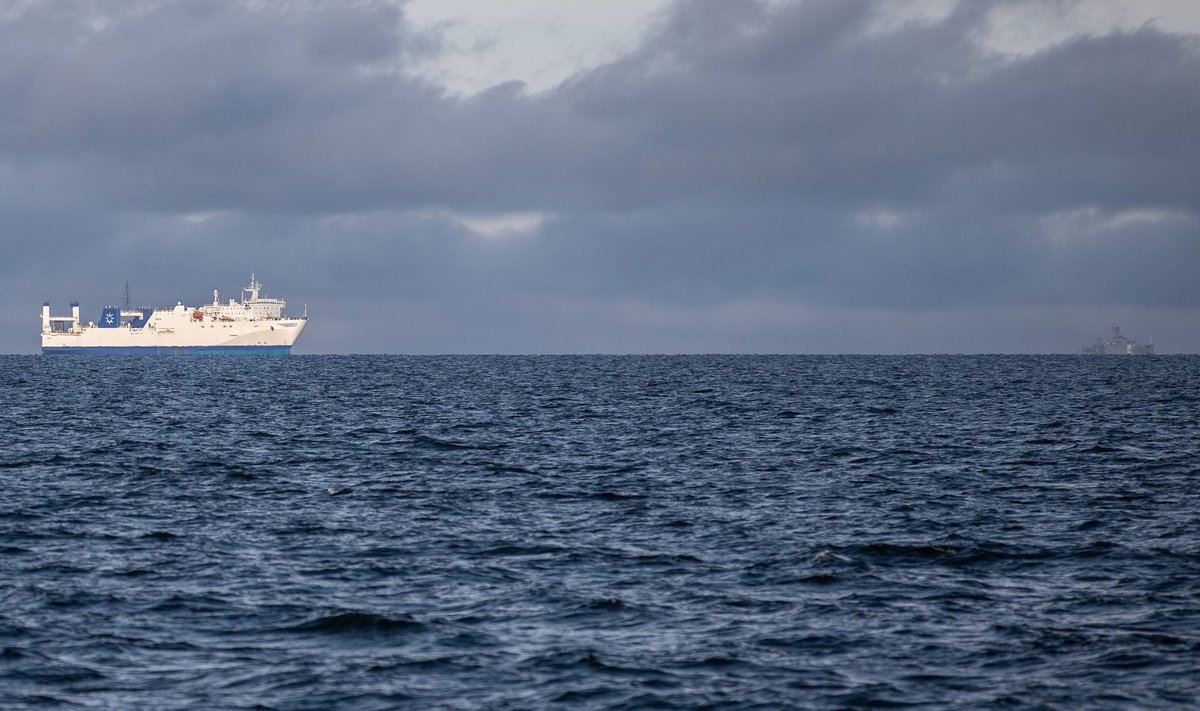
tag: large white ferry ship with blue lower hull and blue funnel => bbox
[42,274,308,356]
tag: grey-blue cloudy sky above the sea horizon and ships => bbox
[0,0,1200,353]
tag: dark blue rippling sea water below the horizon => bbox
[0,356,1200,710]
